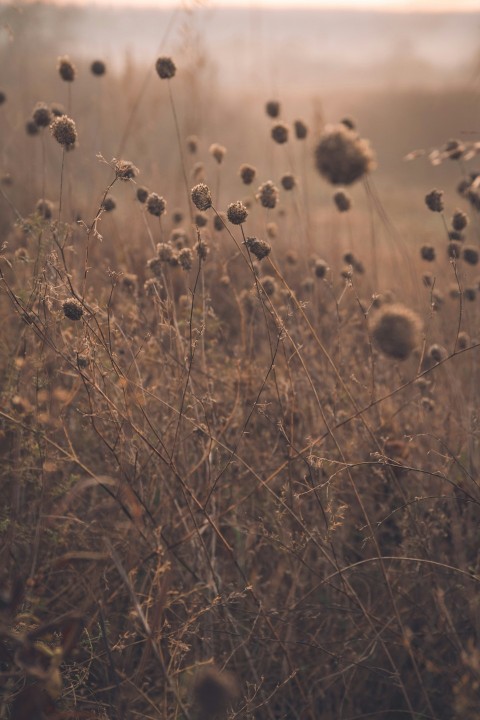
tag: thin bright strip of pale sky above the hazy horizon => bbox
[42,0,480,12]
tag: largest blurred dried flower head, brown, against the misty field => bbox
[315,124,375,185]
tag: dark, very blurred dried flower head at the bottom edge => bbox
[193,667,238,720]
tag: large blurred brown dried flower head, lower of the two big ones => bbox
[372,303,422,360]
